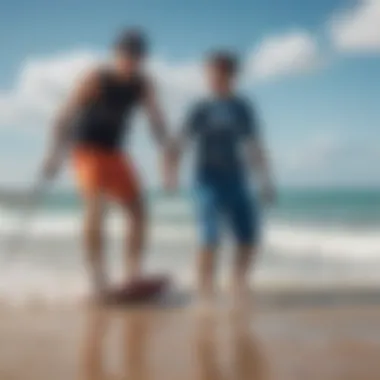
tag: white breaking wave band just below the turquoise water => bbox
[0,206,380,260]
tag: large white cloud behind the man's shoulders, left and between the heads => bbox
[0,51,202,127]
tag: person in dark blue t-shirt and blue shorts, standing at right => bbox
[168,51,274,301]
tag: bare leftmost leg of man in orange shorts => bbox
[84,194,107,296]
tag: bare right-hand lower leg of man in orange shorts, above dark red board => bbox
[125,197,146,281]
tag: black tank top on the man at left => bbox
[73,70,145,150]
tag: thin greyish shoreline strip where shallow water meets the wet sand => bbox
[0,281,380,312]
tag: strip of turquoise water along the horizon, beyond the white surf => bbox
[27,189,380,227]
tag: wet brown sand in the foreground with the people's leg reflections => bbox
[0,294,380,380]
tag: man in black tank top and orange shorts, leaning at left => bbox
[44,30,167,297]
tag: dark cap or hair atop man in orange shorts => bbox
[114,28,148,57]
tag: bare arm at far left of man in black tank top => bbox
[42,72,99,179]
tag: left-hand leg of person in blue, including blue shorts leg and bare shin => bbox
[197,186,219,299]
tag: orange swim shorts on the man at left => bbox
[73,146,141,203]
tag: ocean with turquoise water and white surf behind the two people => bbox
[0,189,380,303]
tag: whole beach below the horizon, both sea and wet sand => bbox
[0,191,380,380]
